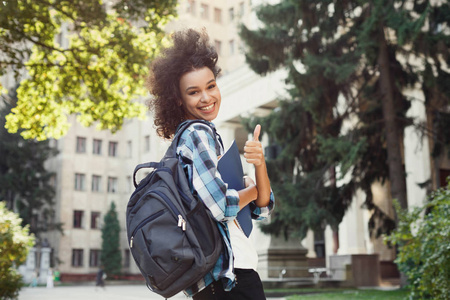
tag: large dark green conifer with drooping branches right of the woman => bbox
[240,0,450,236]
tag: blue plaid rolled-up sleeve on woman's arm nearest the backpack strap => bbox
[177,124,239,222]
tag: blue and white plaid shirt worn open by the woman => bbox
[177,123,275,297]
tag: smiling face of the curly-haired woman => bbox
[180,67,221,121]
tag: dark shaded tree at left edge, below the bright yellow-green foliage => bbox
[0,91,60,236]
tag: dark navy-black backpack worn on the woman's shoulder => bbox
[126,120,223,298]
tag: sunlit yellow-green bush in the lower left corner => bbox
[0,201,34,300]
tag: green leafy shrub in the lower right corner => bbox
[385,181,450,299]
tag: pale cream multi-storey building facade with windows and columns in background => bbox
[5,0,450,280]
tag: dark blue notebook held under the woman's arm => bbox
[217,141,253,237]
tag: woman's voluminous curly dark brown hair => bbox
[147,29,220,139]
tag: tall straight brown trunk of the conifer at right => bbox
[378,26,408,209]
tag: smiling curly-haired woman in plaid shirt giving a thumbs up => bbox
[148,29,274,300]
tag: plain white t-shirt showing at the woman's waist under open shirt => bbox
[228,220,258,270]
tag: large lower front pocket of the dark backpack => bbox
[130,209,194,290]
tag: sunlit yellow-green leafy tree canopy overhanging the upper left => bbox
[0,0,177,140]
